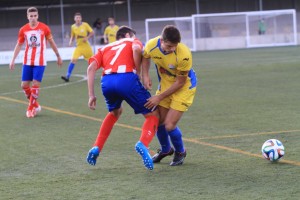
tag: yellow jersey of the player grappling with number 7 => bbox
[143,36,197,91]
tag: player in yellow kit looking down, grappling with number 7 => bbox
[142,25,197,166]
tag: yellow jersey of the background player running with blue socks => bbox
[71,22,93,47]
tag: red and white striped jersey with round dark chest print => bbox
[18,22,52,66]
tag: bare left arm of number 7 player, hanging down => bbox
[87,61,97,110]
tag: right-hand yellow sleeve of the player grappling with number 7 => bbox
[177,45,192,71]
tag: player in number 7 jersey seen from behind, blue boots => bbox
[87,26,158,170]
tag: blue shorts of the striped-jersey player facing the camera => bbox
[22,65,45,82]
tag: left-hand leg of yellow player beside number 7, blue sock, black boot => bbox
[152,106,174,163]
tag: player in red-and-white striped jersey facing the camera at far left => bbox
[9,7,62,118]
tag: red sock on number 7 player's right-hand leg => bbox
[140,115,158,147]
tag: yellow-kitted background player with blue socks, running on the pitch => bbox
[61,13,94,82]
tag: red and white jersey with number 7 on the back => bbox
[89,38,143,74]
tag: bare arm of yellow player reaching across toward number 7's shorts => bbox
[145,71,188,109]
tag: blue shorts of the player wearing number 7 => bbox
[101,73,151,114]
